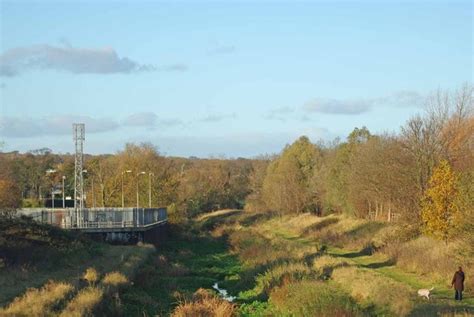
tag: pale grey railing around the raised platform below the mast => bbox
[18,208,168,229]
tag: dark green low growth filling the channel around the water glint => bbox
[123,222,241,316]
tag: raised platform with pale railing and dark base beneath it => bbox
[17,208,168,243]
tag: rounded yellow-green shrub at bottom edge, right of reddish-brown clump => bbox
[270,281,362,317]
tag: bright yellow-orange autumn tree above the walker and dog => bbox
[421,160,462,243]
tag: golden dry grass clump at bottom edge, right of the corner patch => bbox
[60,286,104,317]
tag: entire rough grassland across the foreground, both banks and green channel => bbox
[0,210,474,316]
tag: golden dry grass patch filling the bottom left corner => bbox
[0,281,74,316]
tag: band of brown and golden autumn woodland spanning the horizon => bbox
[0,84,474,243]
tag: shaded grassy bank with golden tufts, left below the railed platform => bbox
[0,219,154,316]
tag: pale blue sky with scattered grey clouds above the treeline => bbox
[0,0,474,157]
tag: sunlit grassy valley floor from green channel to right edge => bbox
[123,210,474,316]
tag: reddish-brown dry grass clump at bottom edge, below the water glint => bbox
[172,288,237,317]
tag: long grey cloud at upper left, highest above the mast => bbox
[0,45,187,77]
